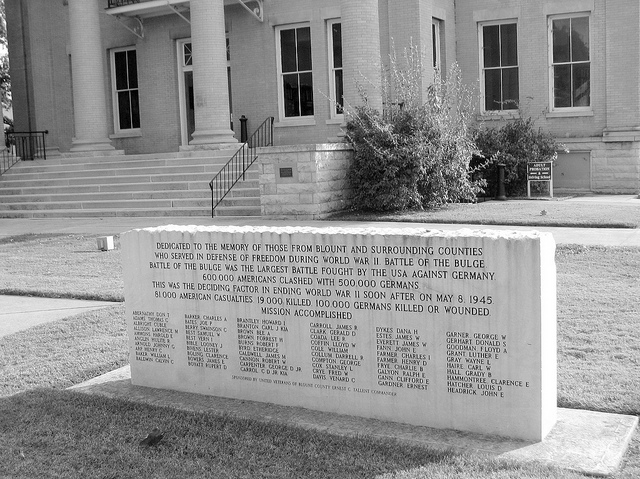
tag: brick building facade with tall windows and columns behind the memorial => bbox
[5,0,640,193]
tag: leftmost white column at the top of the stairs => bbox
[69,0,114,151]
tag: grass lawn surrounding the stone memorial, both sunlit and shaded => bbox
[0,235,640,479]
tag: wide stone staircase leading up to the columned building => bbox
[0,150,260,218]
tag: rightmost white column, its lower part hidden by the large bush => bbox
[340,0,382,111]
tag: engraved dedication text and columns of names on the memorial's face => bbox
[134,236,529,399]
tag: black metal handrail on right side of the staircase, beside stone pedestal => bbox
[209,116,273,217]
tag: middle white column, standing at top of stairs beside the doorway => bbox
[189,0,237,146]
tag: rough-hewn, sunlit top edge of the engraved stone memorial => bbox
[124,224,552,239]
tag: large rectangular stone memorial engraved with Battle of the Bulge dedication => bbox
[121,226,556,441]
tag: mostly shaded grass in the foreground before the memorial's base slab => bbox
[0,389,580,478]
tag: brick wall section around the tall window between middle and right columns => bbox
[232,0,348,145]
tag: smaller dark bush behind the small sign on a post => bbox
[471,113,563,196]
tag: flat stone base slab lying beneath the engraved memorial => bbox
[69,366,638,477]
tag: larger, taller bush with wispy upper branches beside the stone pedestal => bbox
[347,48,479,211]
